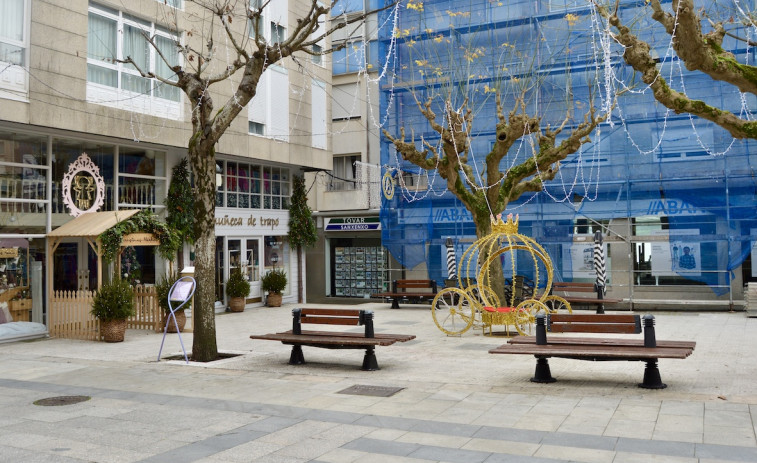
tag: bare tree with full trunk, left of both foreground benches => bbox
[124,0,384,361]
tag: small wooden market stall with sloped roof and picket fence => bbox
[47,210,174,340]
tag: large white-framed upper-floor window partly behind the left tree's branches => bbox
[87,4,181,117]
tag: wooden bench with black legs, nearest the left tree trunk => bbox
[250,308,415,371]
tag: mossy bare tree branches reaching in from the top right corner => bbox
[597,0,757,139]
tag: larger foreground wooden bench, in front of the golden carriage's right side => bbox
[489,314,696,389]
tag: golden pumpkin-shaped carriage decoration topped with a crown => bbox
[431,214,572,335]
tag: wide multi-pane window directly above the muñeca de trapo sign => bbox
[216,161,291,209]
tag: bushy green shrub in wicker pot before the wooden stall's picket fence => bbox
[91,278,134,342]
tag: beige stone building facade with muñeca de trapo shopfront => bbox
[0,0,332,321]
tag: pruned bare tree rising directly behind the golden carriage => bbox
[383,7,606,300]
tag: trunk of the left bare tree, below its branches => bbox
[189,132,218,362]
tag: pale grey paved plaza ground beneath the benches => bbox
[0,303,757,463]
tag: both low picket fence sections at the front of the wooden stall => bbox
[49,285,163,341]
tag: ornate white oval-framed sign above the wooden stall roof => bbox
[62,153,105,217]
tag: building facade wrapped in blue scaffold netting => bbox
[379,0,757,309]
